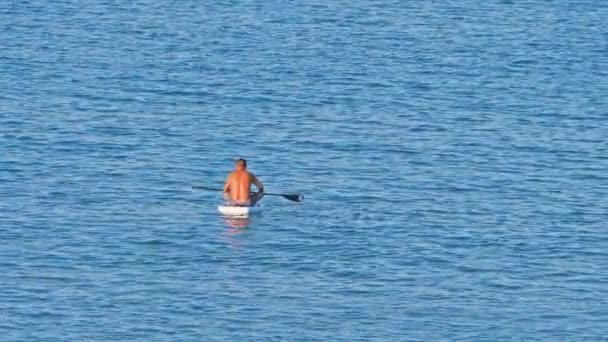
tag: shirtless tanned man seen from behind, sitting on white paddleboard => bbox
[224,158,264,207]
